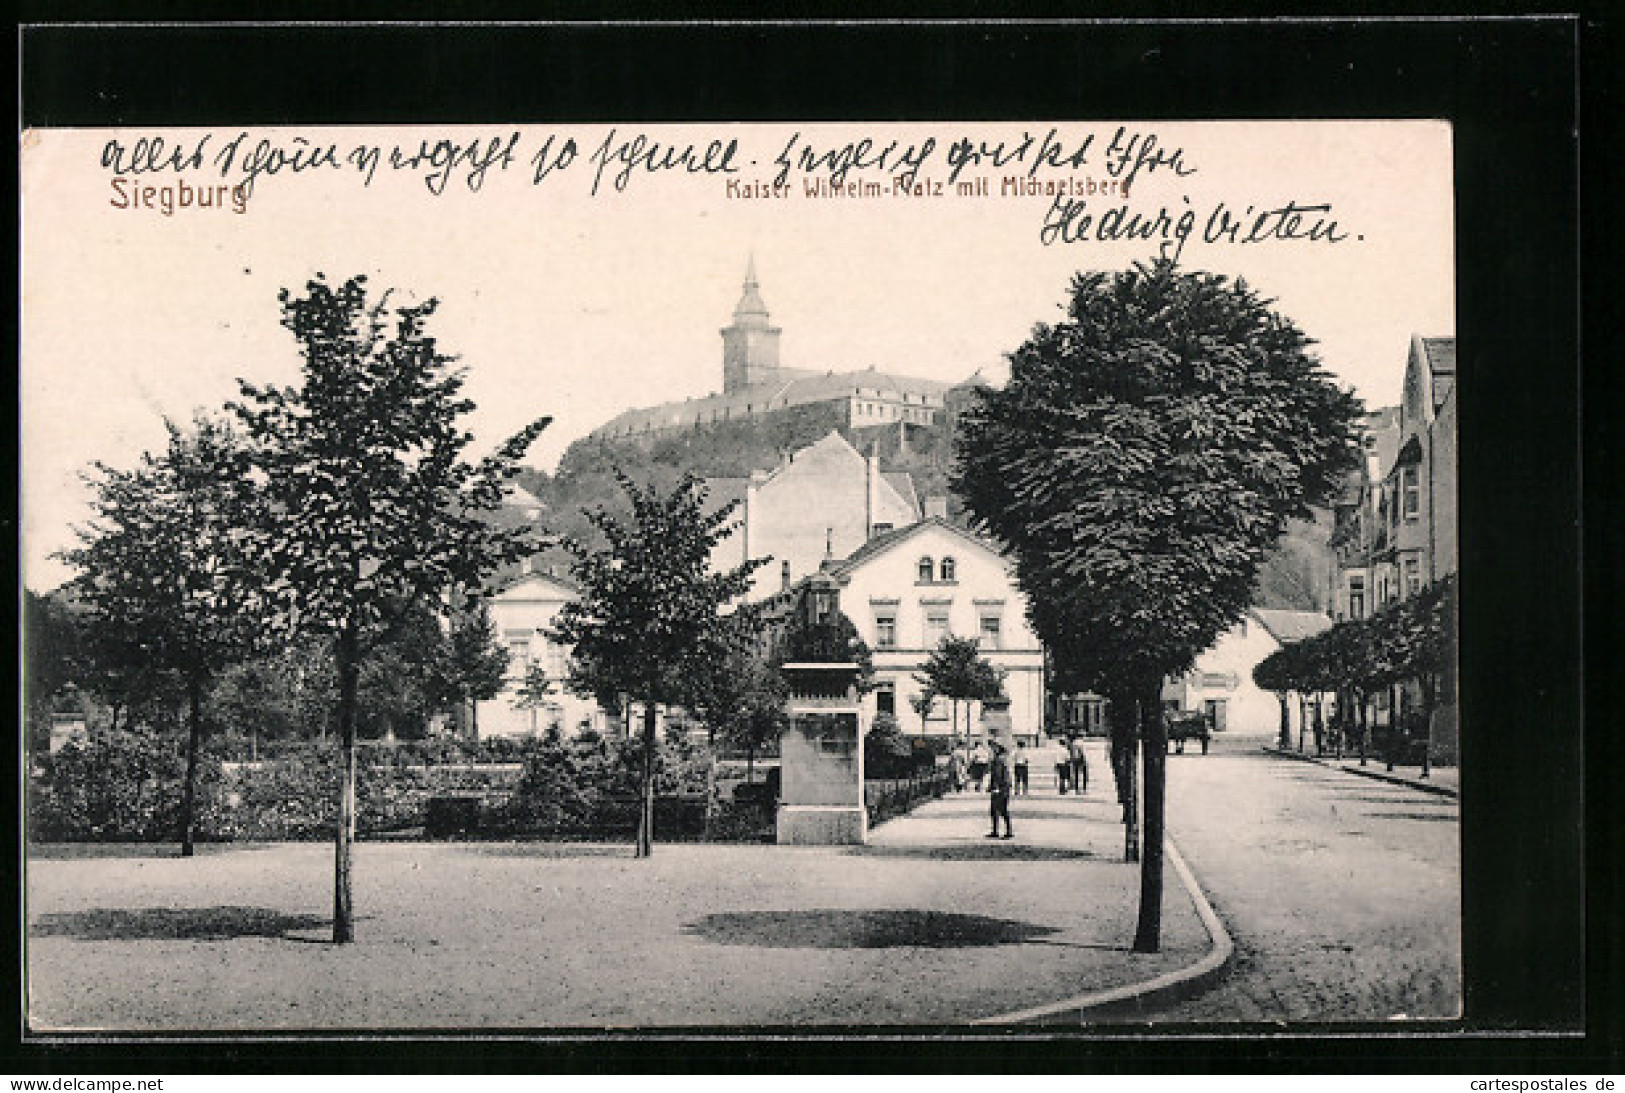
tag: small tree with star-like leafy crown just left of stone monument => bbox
[548,474,765,858]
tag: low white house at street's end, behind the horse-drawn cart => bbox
[1162,607,1331,739]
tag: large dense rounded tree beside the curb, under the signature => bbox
[954,261,1359,952]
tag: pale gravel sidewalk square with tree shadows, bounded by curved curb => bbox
[28,747,1214,1033]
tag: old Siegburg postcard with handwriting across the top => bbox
[20,119,1471,1036]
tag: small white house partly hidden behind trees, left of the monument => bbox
[475,573,611,737]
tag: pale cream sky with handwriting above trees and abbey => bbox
[20,120,1456,591]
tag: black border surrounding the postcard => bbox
[7,17,1599,1074]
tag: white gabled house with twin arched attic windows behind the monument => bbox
[829,516,1043,739]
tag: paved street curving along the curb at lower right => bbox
[1159,741,1461,1022]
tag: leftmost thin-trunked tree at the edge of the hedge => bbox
[63,417,263,856]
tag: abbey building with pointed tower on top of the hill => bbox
[590,260,954,442]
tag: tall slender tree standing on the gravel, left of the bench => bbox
[234,276,548,942]
